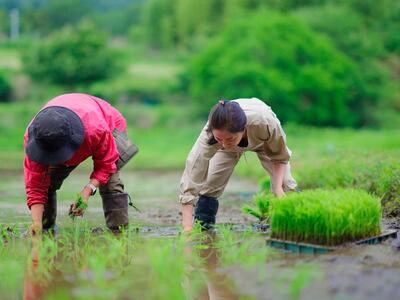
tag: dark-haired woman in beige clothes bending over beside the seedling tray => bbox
[179,98,297,231]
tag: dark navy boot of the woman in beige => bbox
[194,195,219,230]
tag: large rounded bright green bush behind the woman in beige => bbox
[188,12,364,126]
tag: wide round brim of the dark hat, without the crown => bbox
[25,106,85,165]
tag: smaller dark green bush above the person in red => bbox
[24,22,116,85]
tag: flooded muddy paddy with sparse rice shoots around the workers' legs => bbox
[0,171,400,300]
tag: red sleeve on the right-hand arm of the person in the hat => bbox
[90,130,119,185]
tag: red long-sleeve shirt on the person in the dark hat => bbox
[24,94,126,208]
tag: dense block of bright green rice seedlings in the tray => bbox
[270,189,381,246]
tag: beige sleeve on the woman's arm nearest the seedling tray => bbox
[260,118,291,164]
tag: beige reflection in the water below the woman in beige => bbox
[188,233,239,300]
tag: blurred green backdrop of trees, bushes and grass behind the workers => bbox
[0,0,400,216]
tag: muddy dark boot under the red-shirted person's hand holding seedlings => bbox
[101,193,129,232]
